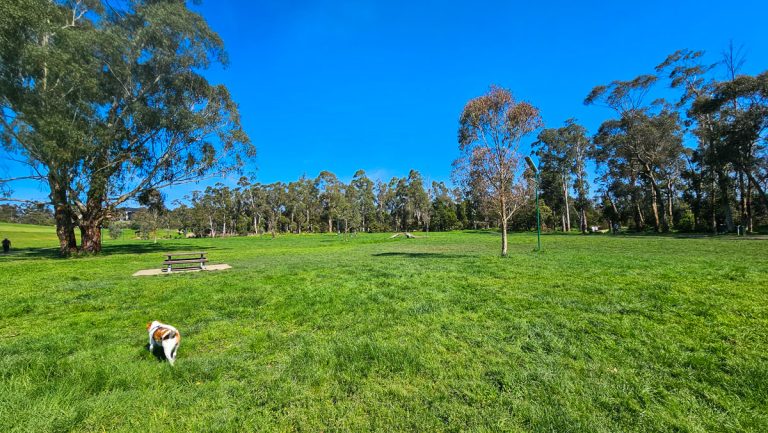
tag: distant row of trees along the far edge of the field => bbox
[147,170,510,236]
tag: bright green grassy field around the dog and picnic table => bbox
[0,224,768,432]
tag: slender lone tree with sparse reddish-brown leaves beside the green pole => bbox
[454,86,543,256]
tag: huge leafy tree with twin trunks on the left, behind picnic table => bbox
[0,0,253,253]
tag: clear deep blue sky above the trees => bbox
[6,0,768,201]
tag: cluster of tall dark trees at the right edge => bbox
[585,47,768,233]
